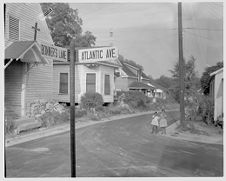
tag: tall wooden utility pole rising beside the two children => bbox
[178,2,185,124]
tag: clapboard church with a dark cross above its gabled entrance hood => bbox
[4,3,53,118]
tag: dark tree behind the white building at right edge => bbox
[200,62,223,95]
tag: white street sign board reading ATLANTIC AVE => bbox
[78,47,118,63]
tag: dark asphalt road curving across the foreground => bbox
[6,115,223,177]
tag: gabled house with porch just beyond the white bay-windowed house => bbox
[115,61,154,95]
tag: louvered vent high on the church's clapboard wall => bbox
[9,16,19,41]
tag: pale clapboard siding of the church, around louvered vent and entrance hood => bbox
[4,3,53,116]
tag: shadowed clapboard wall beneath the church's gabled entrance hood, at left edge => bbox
[5,61,24,118]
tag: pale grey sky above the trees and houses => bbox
[70,2,223,78]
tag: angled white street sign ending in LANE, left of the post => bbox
[40,43,68,62]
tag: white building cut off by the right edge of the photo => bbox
[210,68,224,121]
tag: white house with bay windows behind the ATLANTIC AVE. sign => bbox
[53,47,121,104]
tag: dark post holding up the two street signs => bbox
[70,39,76,177]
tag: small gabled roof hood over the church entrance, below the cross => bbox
[5,41,48,63]
